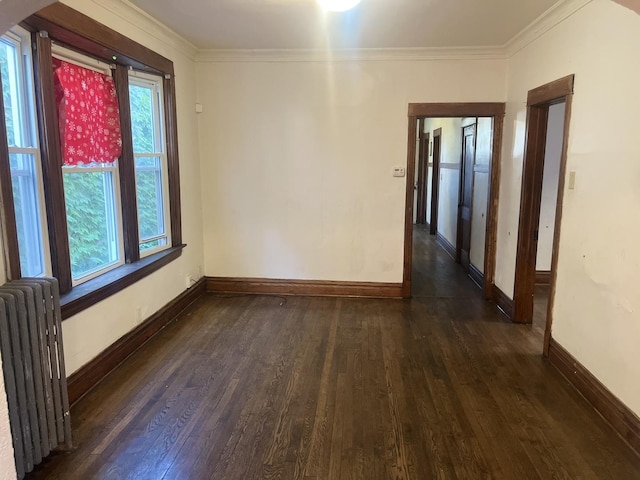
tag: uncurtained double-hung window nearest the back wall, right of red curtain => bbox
[129,70,171,257]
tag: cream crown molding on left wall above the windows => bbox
[62,0,198,60]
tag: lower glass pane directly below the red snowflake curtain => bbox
[63,169,120,280]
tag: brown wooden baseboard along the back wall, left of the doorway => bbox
[207,277,402,298]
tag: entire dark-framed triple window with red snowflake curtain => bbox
[0,3,184,318]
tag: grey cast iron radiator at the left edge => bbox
[0,278,72,478]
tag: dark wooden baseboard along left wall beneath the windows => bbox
[67,278,206,404]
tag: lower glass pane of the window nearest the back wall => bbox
[136,157,166,244]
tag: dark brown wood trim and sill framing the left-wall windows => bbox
[0,3,185,318]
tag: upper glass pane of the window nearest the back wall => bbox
[129,84,158,153]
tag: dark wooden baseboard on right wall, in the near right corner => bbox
[549,338,640,455]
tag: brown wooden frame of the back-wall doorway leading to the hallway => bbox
[402,102,506,299]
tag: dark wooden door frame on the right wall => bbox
[512,75,574,336]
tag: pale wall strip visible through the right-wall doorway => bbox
[536,103,566,271]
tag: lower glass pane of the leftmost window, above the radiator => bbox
[9,153,45,277]
